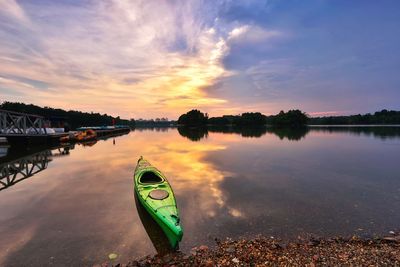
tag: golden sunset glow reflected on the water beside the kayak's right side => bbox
[91,131,248,233]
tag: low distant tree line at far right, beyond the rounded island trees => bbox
[310,109,400,125]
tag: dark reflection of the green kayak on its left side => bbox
[134,194,175,255]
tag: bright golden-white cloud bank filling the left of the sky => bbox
[0,1,234,117]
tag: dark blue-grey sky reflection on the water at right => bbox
[202,131,400,241]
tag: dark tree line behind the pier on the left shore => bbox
[0,102,135,129]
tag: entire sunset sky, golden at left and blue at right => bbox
[0,0,400,119]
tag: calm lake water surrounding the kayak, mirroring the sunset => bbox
[0,127,400,266]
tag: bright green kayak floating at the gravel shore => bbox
[134,157,183,248]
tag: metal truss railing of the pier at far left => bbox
[0,109,47,135]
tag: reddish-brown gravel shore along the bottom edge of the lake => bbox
[106,234,400,267]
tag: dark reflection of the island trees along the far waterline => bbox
[178,126,400,141]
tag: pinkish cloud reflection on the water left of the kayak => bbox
[0,138,156,265]
